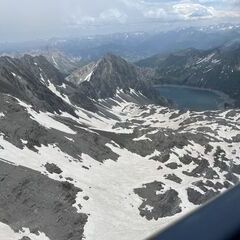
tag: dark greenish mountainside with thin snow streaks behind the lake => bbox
[138,41,240,106]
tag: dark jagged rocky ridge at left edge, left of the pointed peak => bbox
[0,55,73,113]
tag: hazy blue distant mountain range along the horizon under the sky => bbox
[0,24,240,63]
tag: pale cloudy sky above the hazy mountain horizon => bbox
[0,0,240,41]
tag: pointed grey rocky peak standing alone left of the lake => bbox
[67,54,164,104]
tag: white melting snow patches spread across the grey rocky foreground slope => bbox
[0,89,240,240]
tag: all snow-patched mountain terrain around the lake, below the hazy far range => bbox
[0,39,240,240]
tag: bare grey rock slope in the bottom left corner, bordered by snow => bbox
[0,162,87,240]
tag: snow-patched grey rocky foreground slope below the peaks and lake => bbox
[0,54,240,240]
